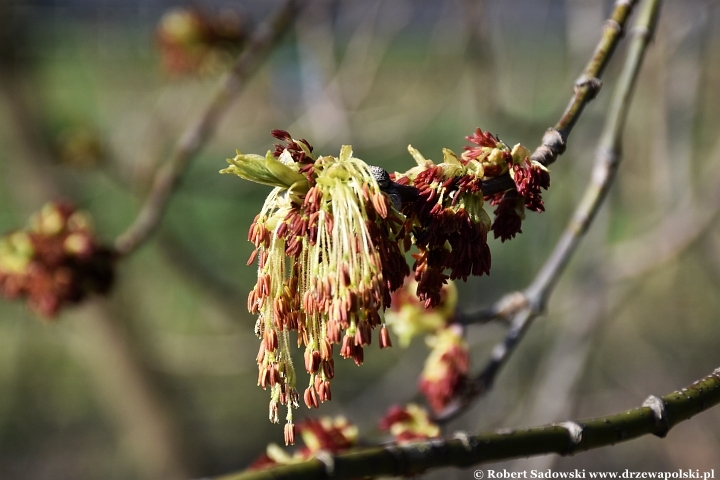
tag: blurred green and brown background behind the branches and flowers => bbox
[0,0,720,480]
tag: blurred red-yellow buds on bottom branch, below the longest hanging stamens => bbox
[248,417,358,470]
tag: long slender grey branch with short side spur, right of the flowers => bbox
[438,0,660,421]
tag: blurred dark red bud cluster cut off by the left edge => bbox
[0,202,113,318]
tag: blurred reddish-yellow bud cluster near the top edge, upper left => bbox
[157,8,245,75]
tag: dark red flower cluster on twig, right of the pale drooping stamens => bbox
[394,128,550,307]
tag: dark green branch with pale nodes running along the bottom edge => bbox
[218,369,720,480]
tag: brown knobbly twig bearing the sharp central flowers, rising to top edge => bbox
[483,0,638,195]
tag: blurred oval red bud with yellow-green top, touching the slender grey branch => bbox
[419,324,470,413]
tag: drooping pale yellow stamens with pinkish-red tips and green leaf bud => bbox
[222,130,409,443]
